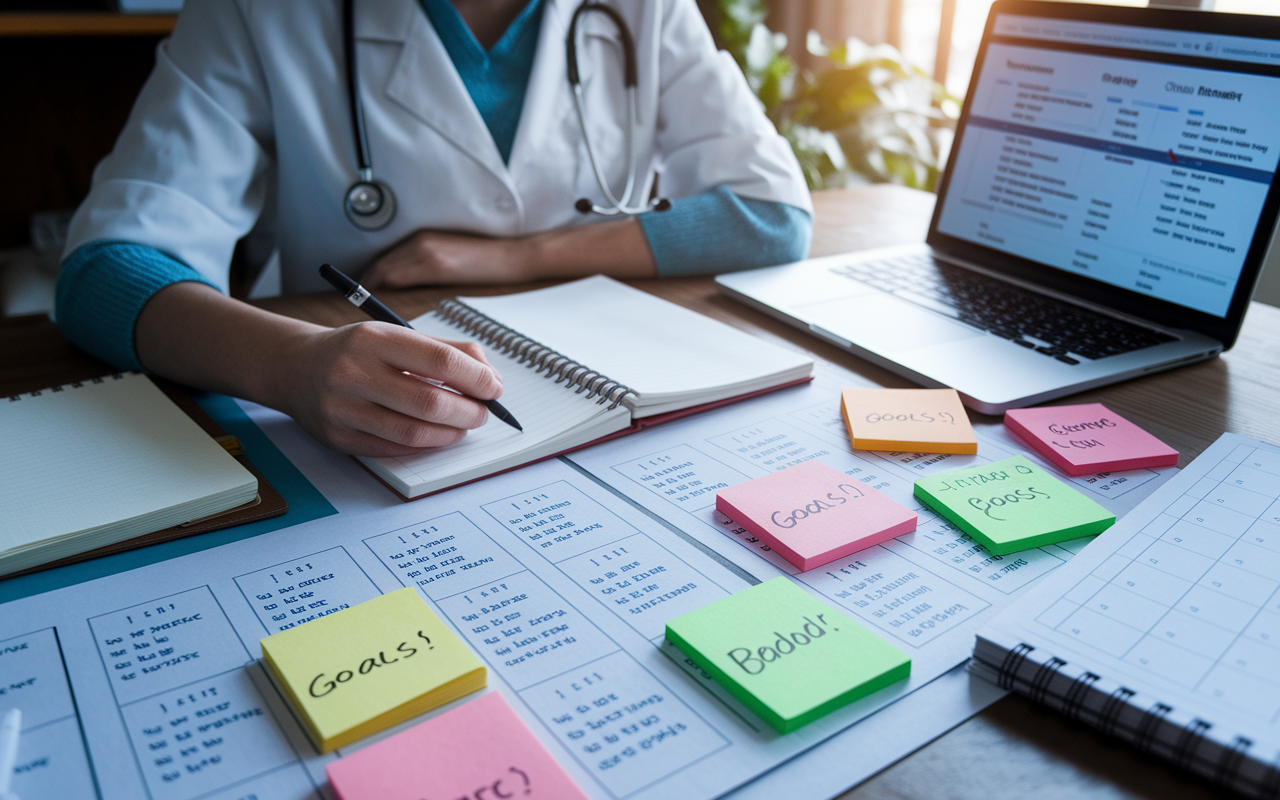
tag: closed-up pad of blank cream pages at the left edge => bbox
[0,372,257,575]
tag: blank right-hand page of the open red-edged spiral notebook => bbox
[458,275,813,416]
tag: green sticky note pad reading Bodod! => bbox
[667,577,911,733]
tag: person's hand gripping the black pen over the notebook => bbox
[276,323,502,456]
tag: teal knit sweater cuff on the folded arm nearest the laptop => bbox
[637,187,813,278]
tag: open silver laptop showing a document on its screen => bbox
[716,0,1280,413]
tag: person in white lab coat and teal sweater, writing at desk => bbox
[56,0,812,456]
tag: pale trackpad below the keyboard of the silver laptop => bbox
[792,292,987,355]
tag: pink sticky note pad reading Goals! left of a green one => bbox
[716,461,915,570]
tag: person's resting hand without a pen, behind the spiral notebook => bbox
[360,230,534,289]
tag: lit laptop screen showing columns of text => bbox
[934,5,1280,317]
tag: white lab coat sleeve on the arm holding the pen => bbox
[65,0,274,292]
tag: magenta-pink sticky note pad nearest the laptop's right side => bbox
[1005,403,1178,475]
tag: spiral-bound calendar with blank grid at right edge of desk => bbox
[970,434,1280,797]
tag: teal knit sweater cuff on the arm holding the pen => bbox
[55,242,218,370]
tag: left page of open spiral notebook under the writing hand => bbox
[361,314,631,497]
